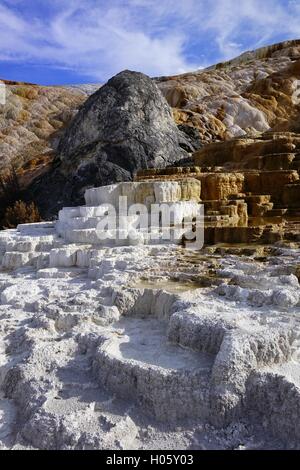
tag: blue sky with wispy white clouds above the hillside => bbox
[0,0,300,84]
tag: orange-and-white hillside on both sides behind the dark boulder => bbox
[0,40,300,216]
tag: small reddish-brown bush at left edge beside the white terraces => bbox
[2,201,42,228]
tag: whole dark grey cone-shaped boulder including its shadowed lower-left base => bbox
[32,70,193,217]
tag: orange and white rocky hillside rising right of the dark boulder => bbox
[157,40,300,143]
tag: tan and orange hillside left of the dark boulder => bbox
[0,80,87,173]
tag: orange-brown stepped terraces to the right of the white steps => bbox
[137,132,300,244]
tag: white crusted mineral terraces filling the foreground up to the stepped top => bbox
[0,181,300,449]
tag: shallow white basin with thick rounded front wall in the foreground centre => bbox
[93,318,215,422]
